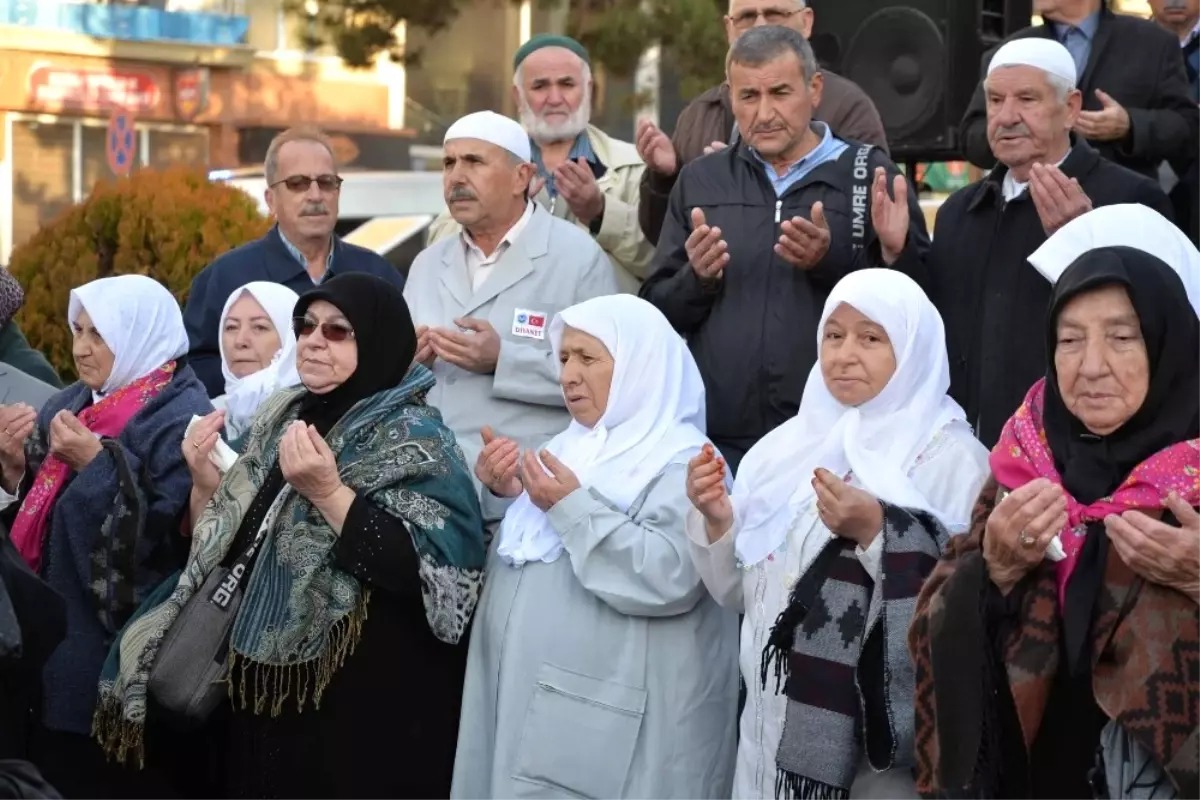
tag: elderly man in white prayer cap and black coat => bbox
[876,38,1170,447]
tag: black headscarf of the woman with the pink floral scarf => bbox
[1043,247,1200,673]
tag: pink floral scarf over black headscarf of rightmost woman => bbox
[989,378,1200,607]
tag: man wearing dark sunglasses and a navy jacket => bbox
[184,128,404,397]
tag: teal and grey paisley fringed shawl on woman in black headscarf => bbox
[94,366,485,760]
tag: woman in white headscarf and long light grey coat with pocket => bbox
[451,295,737,800]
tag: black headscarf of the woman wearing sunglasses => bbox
[293,272,416,435]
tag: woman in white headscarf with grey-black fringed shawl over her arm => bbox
[688,270,988,800]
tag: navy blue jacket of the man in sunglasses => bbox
[184,227,404,397]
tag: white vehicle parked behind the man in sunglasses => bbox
[209,168,445,275]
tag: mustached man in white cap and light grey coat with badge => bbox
[404,112,618,479]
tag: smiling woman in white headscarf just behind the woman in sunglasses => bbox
[212,281,300,450]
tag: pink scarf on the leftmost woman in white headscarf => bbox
[12,361,175,571]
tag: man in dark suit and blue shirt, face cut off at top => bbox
[959,0,1200,179]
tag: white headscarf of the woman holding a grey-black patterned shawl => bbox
[733,270,970,566]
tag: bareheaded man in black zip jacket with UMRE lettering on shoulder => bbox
[641,25,929,469]
